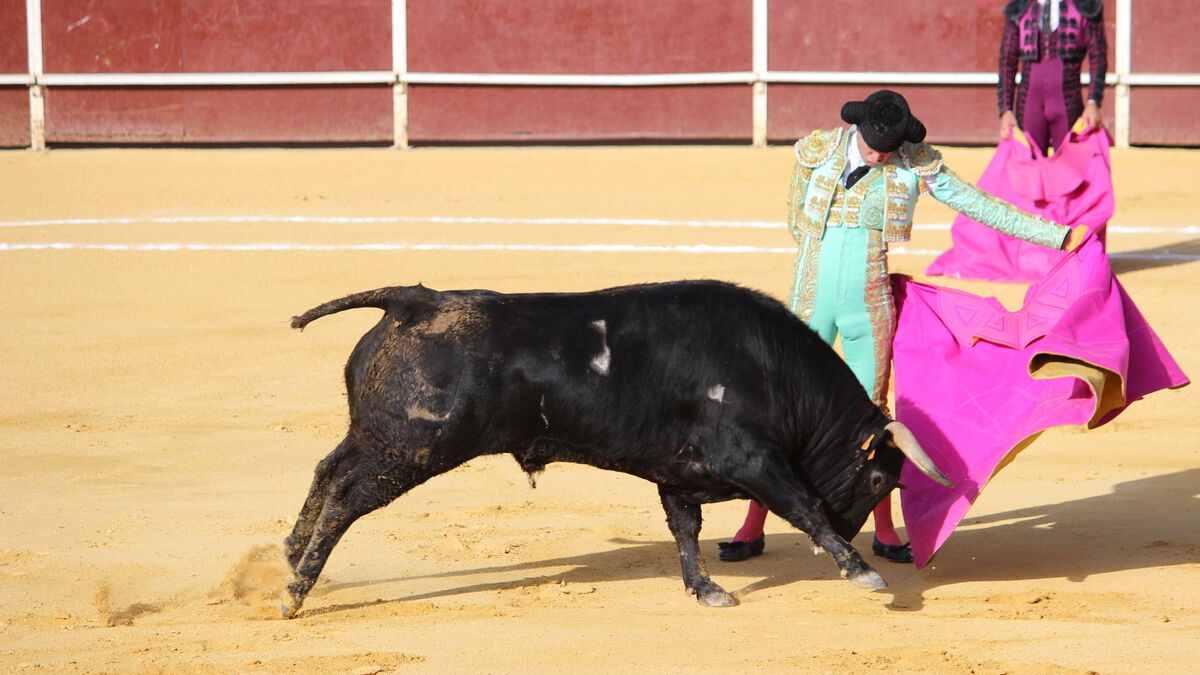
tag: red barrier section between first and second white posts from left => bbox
[42,0,392,143]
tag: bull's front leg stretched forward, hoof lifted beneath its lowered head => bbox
[728,453,888,589]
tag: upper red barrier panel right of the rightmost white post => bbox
[1128,2,1200,72]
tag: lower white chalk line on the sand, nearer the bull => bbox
[0,241,1200,262]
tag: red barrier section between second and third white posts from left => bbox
[408,0,751,142]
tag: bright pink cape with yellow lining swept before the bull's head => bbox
[893,235,1188,567]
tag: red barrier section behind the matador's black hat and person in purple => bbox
[767,0,1115,143]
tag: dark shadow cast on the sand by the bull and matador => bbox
[301,468,1200,616]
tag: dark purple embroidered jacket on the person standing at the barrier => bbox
[997,0,1109,119]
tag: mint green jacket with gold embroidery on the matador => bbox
[787,127,1069,249]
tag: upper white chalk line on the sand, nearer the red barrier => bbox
[0,216,1200,234]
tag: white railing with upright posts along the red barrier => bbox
[9,0,1200,150]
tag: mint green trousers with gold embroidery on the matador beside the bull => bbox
[792,226,895,411]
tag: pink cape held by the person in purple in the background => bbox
[925,127,1114,283]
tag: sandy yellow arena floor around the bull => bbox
[0,140,1200,675]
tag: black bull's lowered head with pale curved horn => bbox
[826,422,954,540]
